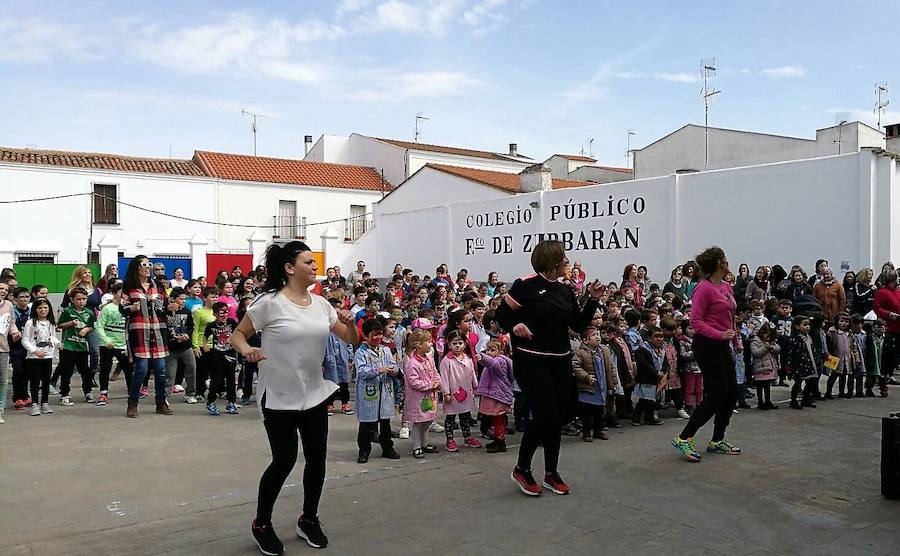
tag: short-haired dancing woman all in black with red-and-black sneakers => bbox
[497,241,603,496]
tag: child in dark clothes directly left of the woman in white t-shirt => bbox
[203,301,238,416]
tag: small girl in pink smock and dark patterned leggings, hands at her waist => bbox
[440,329,481,452]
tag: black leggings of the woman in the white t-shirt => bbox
[256,399,328,524]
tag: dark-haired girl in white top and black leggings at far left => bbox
[22,298,60,416]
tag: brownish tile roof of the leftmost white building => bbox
[0,147,203,176]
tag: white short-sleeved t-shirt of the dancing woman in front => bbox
[247,292,338,411]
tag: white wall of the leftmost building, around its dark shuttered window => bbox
[0,164,217,263]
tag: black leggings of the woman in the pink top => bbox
[680,334,737,442]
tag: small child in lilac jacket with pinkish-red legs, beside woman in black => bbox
[477,340,516,454]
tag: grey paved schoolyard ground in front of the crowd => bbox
[0,381,900,556]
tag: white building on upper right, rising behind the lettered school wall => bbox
[634,122,885,179]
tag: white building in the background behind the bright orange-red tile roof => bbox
[304,133,534,184]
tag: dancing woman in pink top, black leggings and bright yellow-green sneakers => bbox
[672,247,741,462]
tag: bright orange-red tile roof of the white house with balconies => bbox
[194,151,393,191]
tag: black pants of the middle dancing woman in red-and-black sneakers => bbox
[514,350,575,473]
